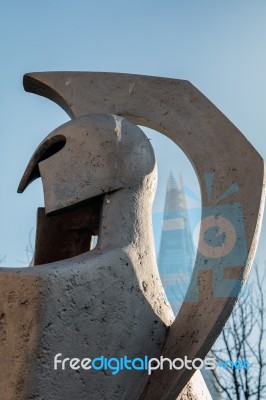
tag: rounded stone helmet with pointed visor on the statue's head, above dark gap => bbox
[18,114,156,214]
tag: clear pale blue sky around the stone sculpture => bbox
[0,0,266,272]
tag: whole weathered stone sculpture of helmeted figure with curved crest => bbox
[0,72,264,400]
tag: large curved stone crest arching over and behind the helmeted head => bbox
[21,72,265,400]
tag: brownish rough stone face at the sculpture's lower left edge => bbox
[0,269,42,400]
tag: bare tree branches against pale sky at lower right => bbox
[212,264,266,400]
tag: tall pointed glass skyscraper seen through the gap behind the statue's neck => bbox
[158,173,195,315]
